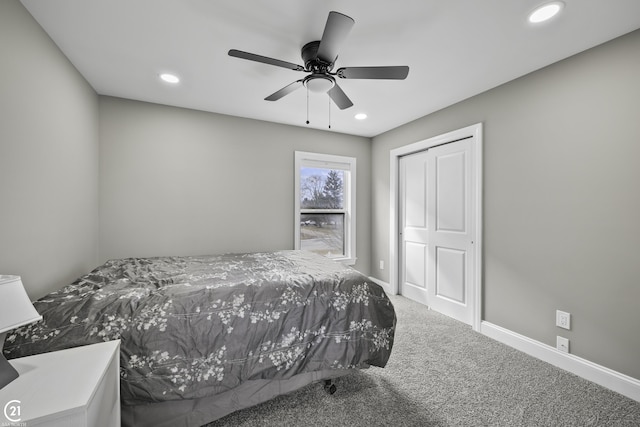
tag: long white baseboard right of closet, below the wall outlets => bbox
[480,321,640,402]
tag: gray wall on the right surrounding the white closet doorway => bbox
[371,31,640,379]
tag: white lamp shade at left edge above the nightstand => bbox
[0,275,42,334]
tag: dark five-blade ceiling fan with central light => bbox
[229,12,409,110]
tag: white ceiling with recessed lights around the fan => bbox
[22,0,640,137]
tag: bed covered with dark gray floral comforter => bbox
[4,251,396,427]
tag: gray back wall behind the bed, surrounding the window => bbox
[100,97,371,274]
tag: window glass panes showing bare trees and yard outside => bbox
[300,167,346,257]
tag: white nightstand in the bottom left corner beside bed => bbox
[0,341,120,427]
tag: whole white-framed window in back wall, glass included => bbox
[295,151,356,264]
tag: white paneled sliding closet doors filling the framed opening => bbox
[398,138,475,324]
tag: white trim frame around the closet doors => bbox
[389,123,483,331]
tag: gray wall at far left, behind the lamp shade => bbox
[0,0,98,299]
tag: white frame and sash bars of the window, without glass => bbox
[294,151,357,265]
